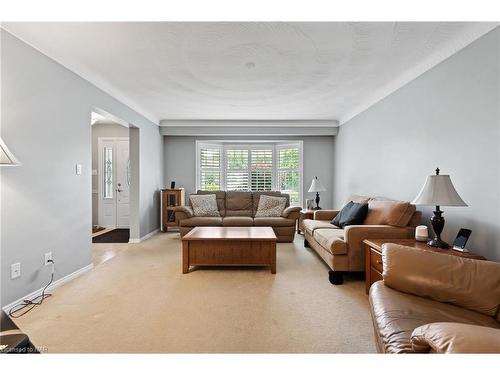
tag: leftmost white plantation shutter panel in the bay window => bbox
[198,144,222,191]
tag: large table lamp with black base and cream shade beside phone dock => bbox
[411,168,467,249]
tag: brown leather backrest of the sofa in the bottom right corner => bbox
[382,243,500,317]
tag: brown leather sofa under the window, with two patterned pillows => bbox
[174,190,302,242]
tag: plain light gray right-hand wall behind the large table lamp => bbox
[334,28,500,261]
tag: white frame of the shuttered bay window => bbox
[196,140,304,207]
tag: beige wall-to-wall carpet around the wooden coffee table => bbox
[16,233,375,353]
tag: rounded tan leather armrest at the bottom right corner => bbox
[411,323,500,354]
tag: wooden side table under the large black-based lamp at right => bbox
[363,238,486,294]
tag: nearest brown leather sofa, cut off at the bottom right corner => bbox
[369,244,500,353]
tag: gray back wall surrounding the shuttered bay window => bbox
[163,137,334,208]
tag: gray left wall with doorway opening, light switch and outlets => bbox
[0,30,163,306]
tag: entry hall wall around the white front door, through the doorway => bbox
[91,123,129,225]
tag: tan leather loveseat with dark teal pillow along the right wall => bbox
[303,195,422,284]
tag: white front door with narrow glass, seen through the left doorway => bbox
[97,138,130,228]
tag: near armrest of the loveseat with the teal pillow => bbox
[344,225,415,248]
